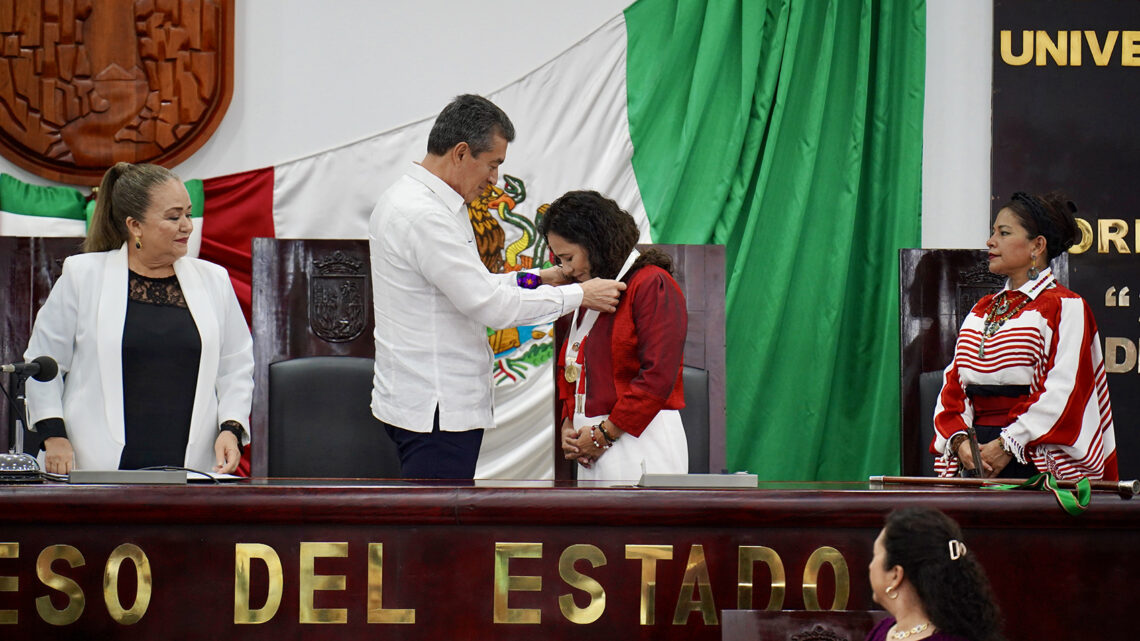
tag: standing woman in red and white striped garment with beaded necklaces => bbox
[930,192,1118,479]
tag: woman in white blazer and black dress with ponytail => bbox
[25,163,253,473]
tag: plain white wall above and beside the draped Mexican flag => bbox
[0,0,992,248]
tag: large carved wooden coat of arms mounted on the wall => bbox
[0,0,234,185]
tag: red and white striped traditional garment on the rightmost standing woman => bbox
[930,269,1118,480]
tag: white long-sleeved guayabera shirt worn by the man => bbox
[368,164,583,432]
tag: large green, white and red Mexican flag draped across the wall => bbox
[0,0,926,480]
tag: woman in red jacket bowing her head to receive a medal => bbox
[539,192,689,480]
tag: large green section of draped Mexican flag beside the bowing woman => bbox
[626,0,926,480]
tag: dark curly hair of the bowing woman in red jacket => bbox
[538,192,673,278]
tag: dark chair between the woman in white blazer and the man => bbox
[251,238,378,477]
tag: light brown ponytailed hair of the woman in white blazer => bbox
[83,162,178,252]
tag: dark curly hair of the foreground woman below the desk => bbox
[882,508,1002,641]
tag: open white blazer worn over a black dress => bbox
[24,244,253,471]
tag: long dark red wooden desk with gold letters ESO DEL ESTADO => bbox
[0,479,1140,640]
